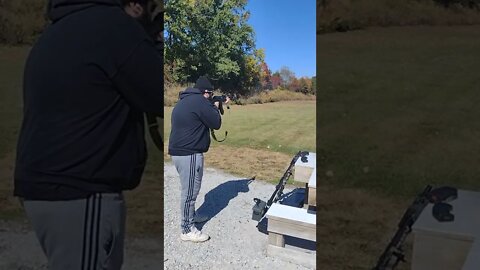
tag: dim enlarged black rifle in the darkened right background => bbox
[373,185,457,270]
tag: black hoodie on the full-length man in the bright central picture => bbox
[168,88,222,156]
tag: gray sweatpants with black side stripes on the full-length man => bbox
[172,153,203,233]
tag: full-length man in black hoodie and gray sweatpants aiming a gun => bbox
[168,77,229,242]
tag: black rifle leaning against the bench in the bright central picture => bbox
[252,151,308,221]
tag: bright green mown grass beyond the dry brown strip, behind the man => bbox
[164,101,316,154]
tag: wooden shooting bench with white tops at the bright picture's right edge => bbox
[266,152,316,269]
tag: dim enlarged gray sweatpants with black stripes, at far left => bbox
[24,193,125,270]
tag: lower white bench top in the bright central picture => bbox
[266,203,317,228]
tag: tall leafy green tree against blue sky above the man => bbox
[165,0,264,93]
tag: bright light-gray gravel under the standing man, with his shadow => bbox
[164,163,314,270]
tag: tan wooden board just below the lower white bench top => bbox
[267,218,317,241]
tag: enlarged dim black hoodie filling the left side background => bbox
[14,0,163,200]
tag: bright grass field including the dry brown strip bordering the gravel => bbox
[164,101,316,183]
